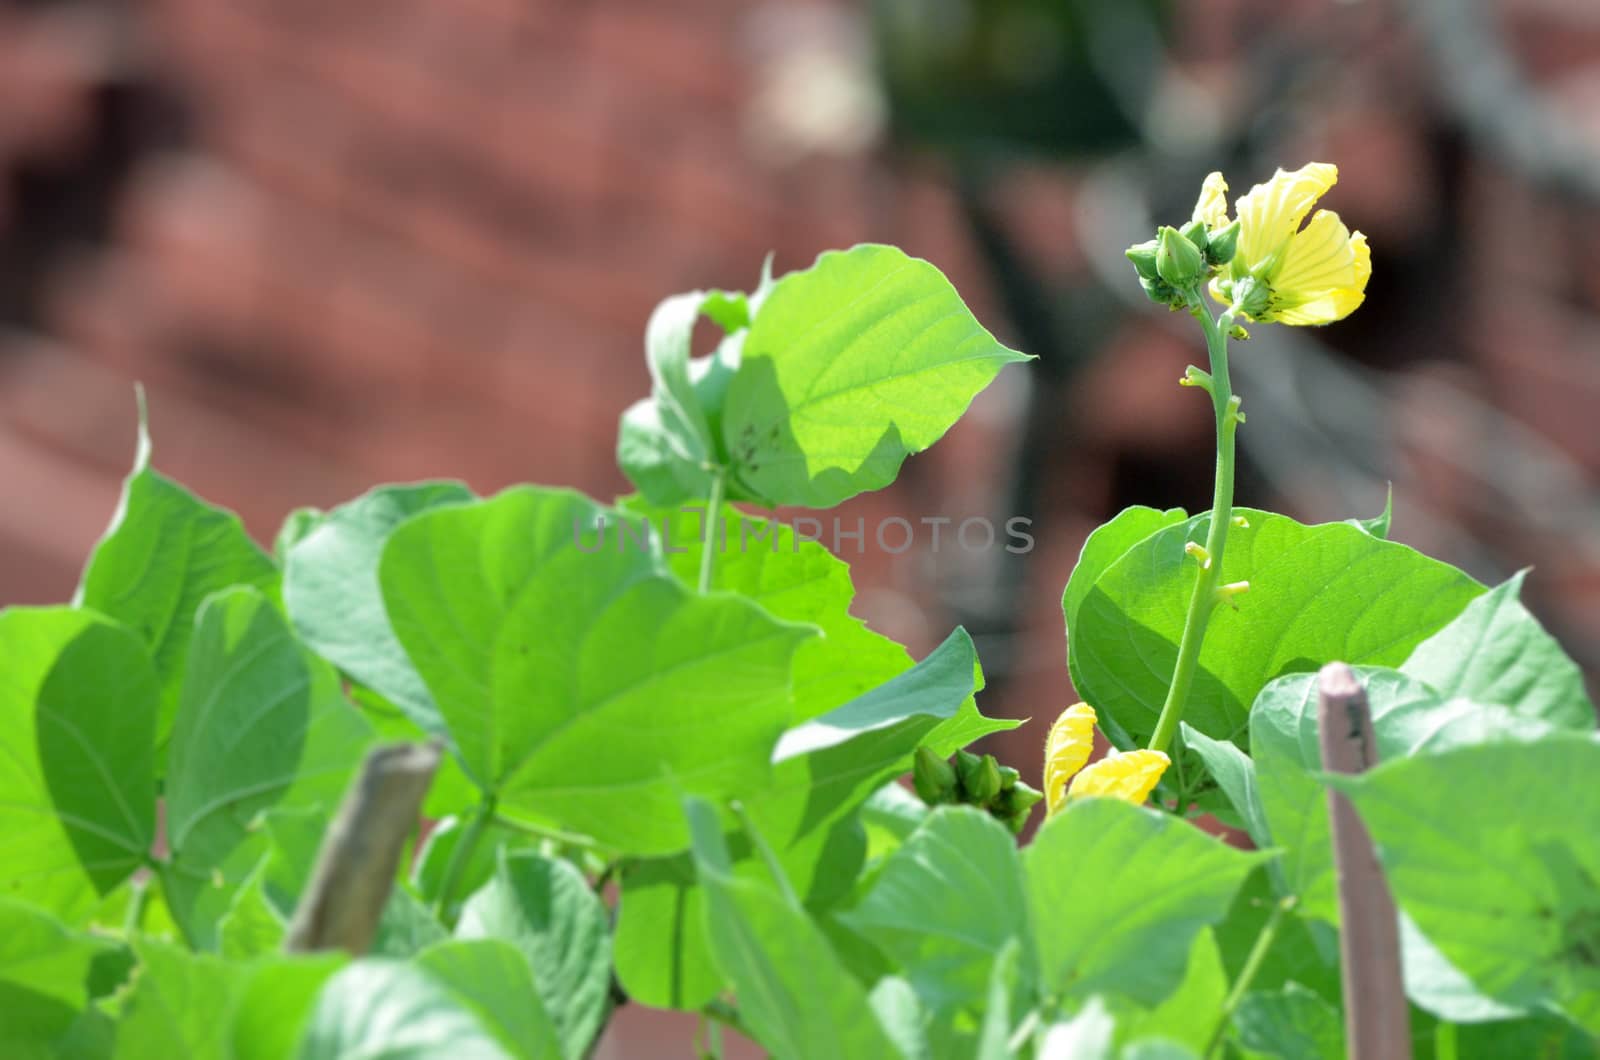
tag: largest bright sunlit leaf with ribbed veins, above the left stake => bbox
[379,487,814,855]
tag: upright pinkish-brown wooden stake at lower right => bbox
[1317,663,1411,1060]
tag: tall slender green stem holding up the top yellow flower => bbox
[1149,302,1238,751]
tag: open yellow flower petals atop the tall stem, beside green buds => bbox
[1195,162,1373,325]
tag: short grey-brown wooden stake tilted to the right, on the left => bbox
[283,743,440,956]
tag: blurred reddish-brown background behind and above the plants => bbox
[0,0,1600,1055]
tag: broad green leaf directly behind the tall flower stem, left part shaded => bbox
[1069,509,1482,743]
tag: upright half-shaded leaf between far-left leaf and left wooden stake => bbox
[166,588,371,890]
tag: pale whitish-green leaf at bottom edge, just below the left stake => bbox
[298,958,515,1060]
